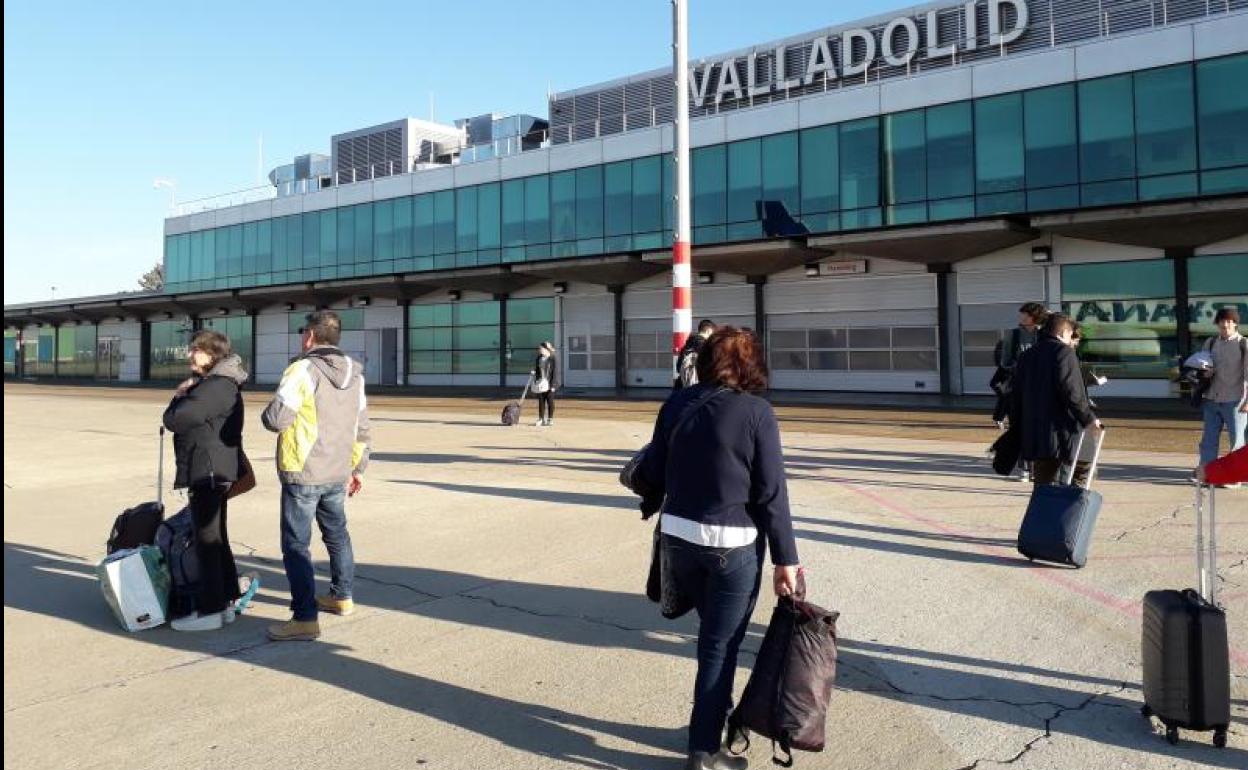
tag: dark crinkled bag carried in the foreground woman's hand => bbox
[728,597,840,768]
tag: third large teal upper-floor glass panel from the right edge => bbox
[1078,75,1136,182]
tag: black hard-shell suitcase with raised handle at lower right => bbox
[1141,485,1231,748]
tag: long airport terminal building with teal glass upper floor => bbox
[5,0,1248,397]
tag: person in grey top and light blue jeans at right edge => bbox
[1201,307,1248,487]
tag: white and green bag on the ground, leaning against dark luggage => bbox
[95,545,170,631]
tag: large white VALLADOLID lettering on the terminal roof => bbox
[689,0,1030,107]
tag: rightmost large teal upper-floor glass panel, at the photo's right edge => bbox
[1196,54,1248,168]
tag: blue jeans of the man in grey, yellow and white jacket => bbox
[282,484,356,620]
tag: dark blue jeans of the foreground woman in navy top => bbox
[663,535,766,754]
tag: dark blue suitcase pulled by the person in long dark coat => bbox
[1018,429,1104,567]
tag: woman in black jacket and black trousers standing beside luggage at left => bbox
[163,329,247,631]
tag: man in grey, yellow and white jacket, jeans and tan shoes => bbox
[261,311,372,641]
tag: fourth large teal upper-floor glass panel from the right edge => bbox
[1023,85,1080,187]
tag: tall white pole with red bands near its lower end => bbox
[671,0,694,376]
